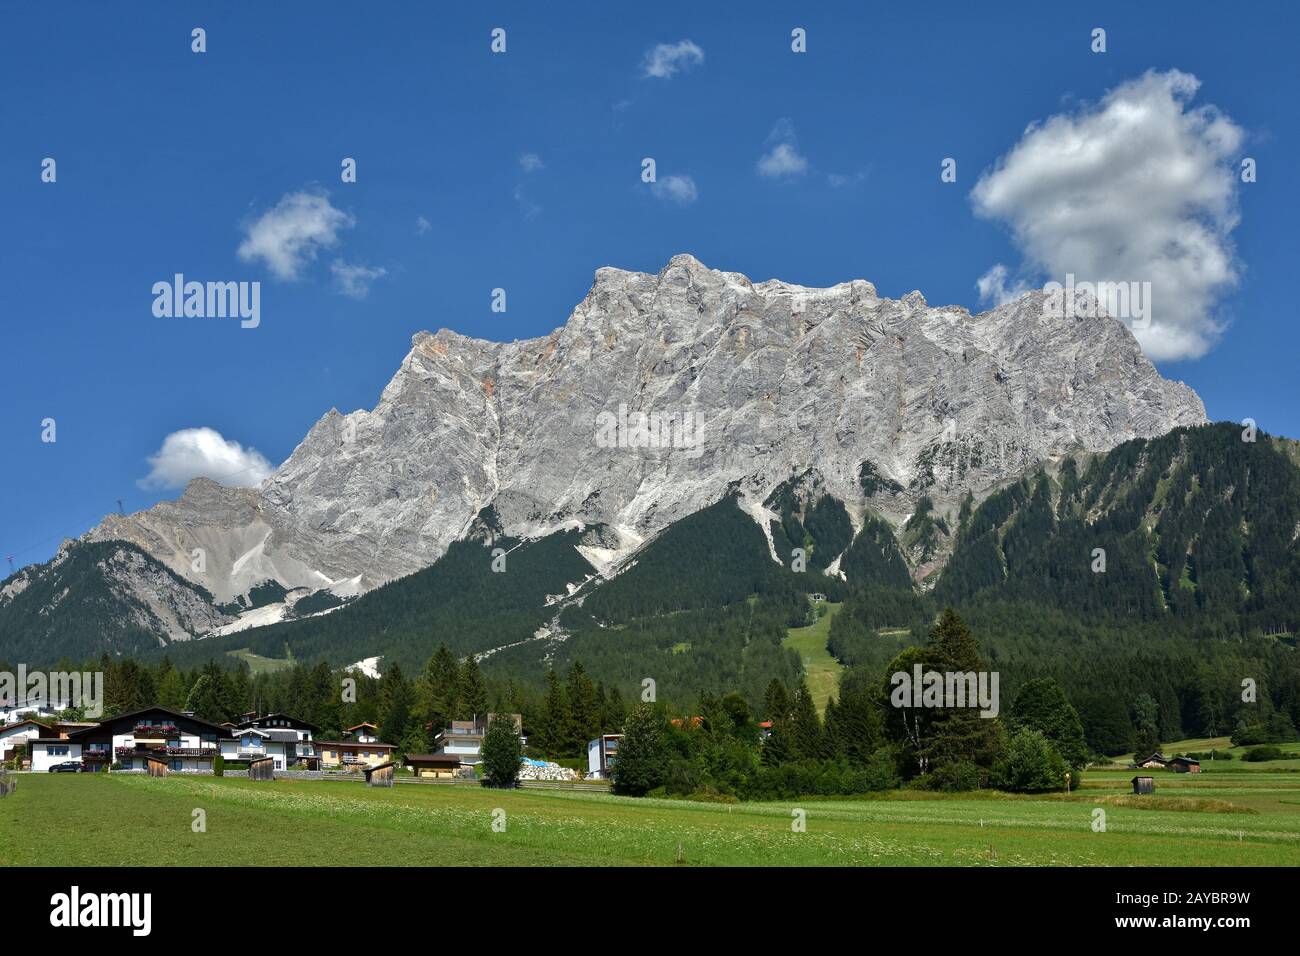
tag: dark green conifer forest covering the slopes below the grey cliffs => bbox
[7,425,1300,797]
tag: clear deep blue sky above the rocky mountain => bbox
[0,3,1300,572]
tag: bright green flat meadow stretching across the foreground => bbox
[0,771,1300,866]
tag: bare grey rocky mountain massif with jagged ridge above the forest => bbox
[87,255,1205,602]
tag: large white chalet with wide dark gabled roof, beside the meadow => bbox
[29,706,226,773]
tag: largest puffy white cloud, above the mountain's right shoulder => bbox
[971,70,1243,359]
